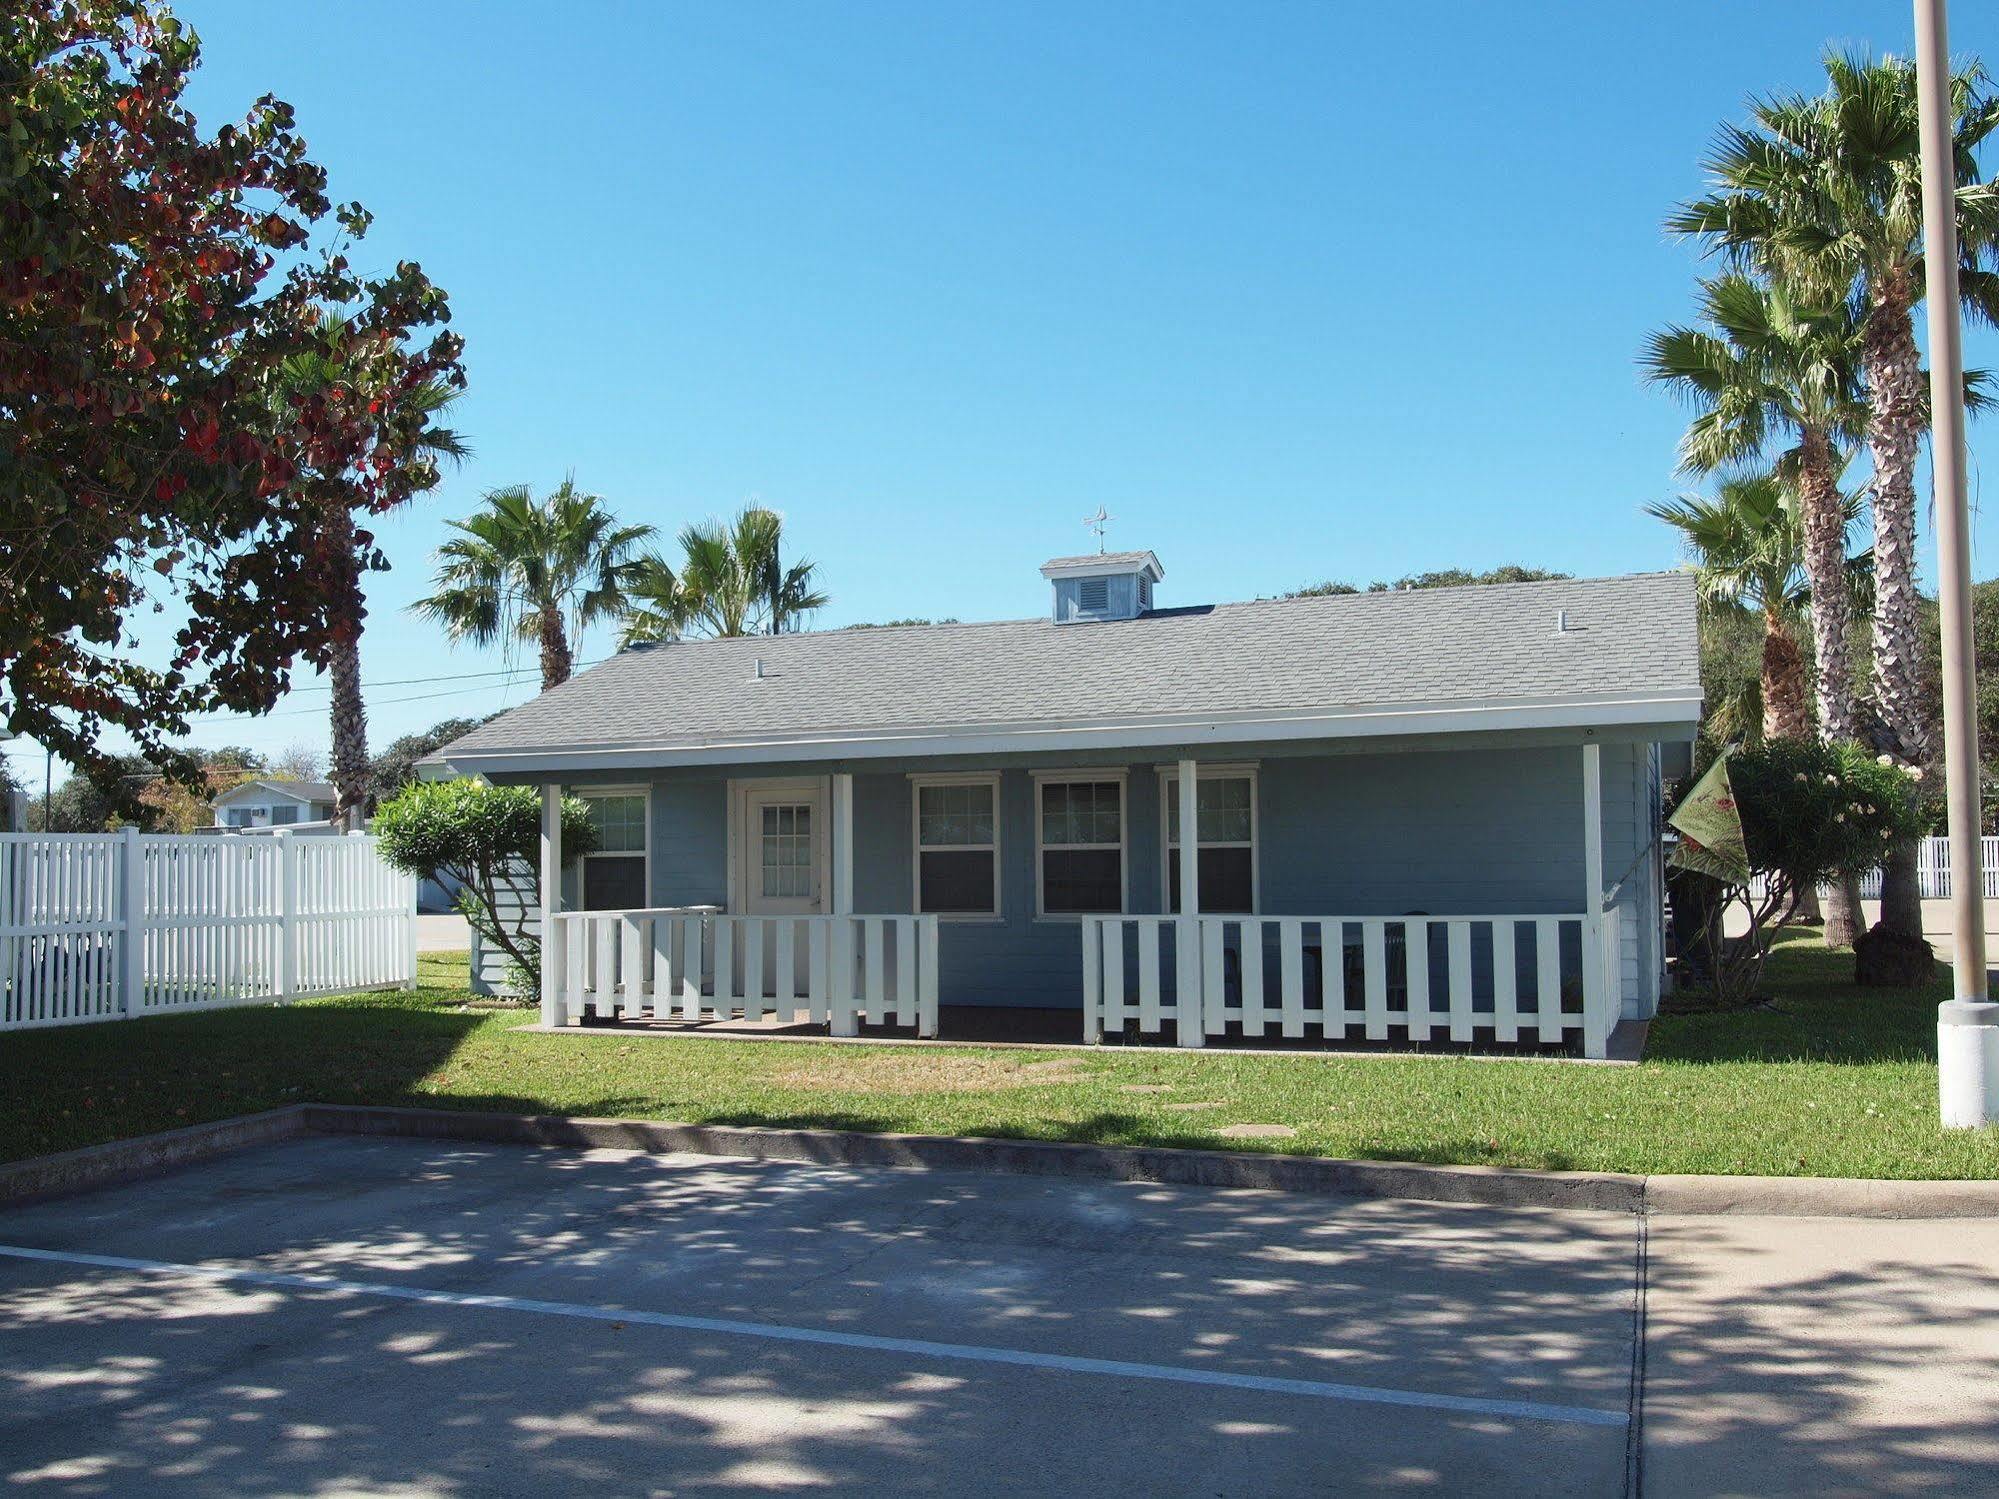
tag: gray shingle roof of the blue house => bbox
[432,572,1699,759]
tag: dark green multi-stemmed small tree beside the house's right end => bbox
[1675,740,1921,1005]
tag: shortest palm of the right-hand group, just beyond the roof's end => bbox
[1645,472,1859,740]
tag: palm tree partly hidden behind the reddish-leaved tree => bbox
[268,319,470,823]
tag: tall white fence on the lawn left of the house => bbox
[0,829,416,1031]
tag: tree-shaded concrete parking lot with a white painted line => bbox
[0,1139,1999,1495]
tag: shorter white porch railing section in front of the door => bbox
[554,907,938,1037]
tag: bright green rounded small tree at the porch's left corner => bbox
[374,781,598,999]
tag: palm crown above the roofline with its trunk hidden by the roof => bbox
[624,506,828,646]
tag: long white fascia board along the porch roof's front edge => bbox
[433,696,1701,775]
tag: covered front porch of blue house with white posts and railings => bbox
[542,740,1657,1057]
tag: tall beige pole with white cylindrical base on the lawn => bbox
[1915,0,1999,1129]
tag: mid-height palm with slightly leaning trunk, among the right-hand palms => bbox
[1643,274,1859,740]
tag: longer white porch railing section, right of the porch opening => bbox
[1083,909,1621,1057]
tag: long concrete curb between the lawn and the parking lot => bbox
[0,1103,1999,1219]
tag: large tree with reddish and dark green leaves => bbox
[0,0,464,811]
